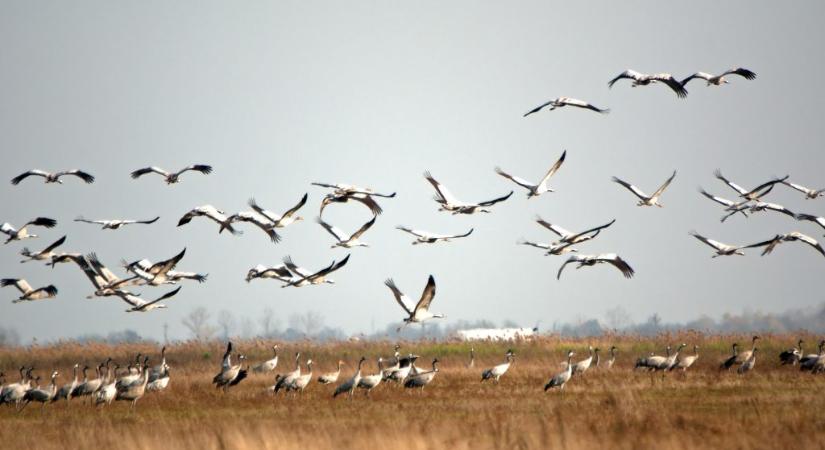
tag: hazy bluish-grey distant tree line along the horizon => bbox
[0,303,825,347]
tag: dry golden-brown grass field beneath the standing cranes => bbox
[0,334,825,450]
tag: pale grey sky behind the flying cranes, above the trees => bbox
[0,1,825,339]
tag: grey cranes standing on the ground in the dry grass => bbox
[6,334,825,412]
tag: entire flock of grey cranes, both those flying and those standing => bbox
[0,67,825,406]
